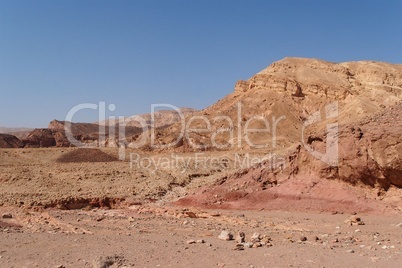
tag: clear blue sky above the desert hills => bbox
[0,0,402,127]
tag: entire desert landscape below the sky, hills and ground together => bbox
[0,58,402,268]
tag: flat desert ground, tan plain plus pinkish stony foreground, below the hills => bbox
[0,148,402,267]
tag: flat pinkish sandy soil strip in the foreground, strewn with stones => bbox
[0,206,402,267]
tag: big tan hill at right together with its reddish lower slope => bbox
[178,58,402,210]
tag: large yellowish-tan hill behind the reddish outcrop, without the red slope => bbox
[148,58,402,150]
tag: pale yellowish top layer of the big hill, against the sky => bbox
[235,58,402,100]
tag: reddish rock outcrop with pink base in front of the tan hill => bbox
[176,103,402,212]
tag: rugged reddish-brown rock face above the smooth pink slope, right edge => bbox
[297,103,402,190]
